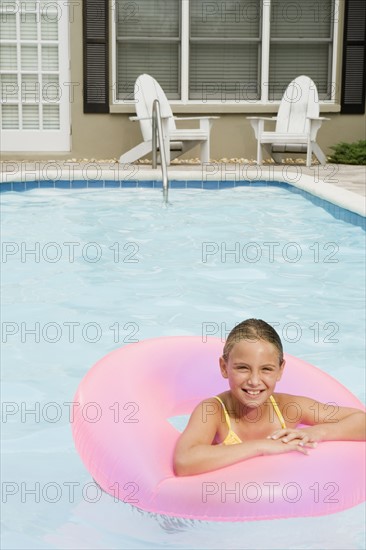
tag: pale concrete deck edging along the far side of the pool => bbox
[0,159,366,216]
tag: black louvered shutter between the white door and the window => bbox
[83,0,109,113]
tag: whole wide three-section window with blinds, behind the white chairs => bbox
[114,0,338,103]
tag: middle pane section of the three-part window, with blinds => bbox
[189,0,261,100]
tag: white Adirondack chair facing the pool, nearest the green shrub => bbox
[247,75,329,166]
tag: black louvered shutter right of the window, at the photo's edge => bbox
[341,0,366,114]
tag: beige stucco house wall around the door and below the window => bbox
[2,3,366,160]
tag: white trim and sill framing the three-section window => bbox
[110,0,341,113]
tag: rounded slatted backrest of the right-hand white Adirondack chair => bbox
[276,76,319,134]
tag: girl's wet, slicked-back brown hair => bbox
[222,319,283,364]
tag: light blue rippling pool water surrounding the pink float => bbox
[1,187,365,550]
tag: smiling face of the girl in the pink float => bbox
[220,340,285,408]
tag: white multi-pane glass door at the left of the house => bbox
[0,0,72,152]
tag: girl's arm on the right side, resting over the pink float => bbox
[271,396,366,444]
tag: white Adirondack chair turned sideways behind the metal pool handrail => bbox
[119,74,219,165]
